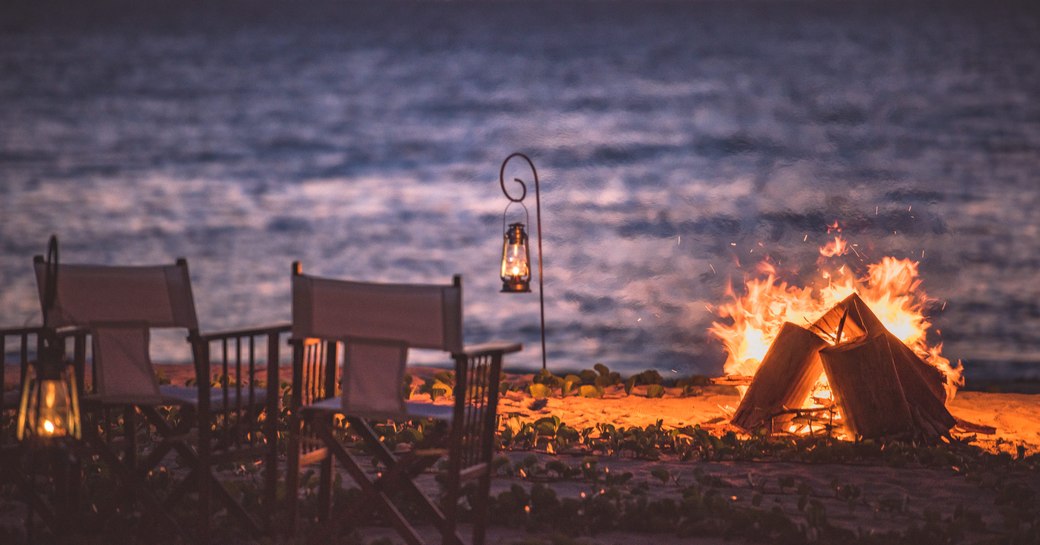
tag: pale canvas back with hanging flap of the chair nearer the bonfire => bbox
[292,274,463,416]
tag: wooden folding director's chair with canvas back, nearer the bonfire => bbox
[287,263,521,545]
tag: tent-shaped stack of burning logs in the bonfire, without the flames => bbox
[732,293,955,439]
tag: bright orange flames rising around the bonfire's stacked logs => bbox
[708,229,964,407]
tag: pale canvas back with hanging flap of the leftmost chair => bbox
[34,256,199,403]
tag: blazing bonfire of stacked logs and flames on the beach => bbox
[710,223,963,438]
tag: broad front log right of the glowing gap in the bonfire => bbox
[820,333,915,438]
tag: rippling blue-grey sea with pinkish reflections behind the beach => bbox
[0,0,1040,381]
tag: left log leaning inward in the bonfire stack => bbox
[732,322,827,432]
